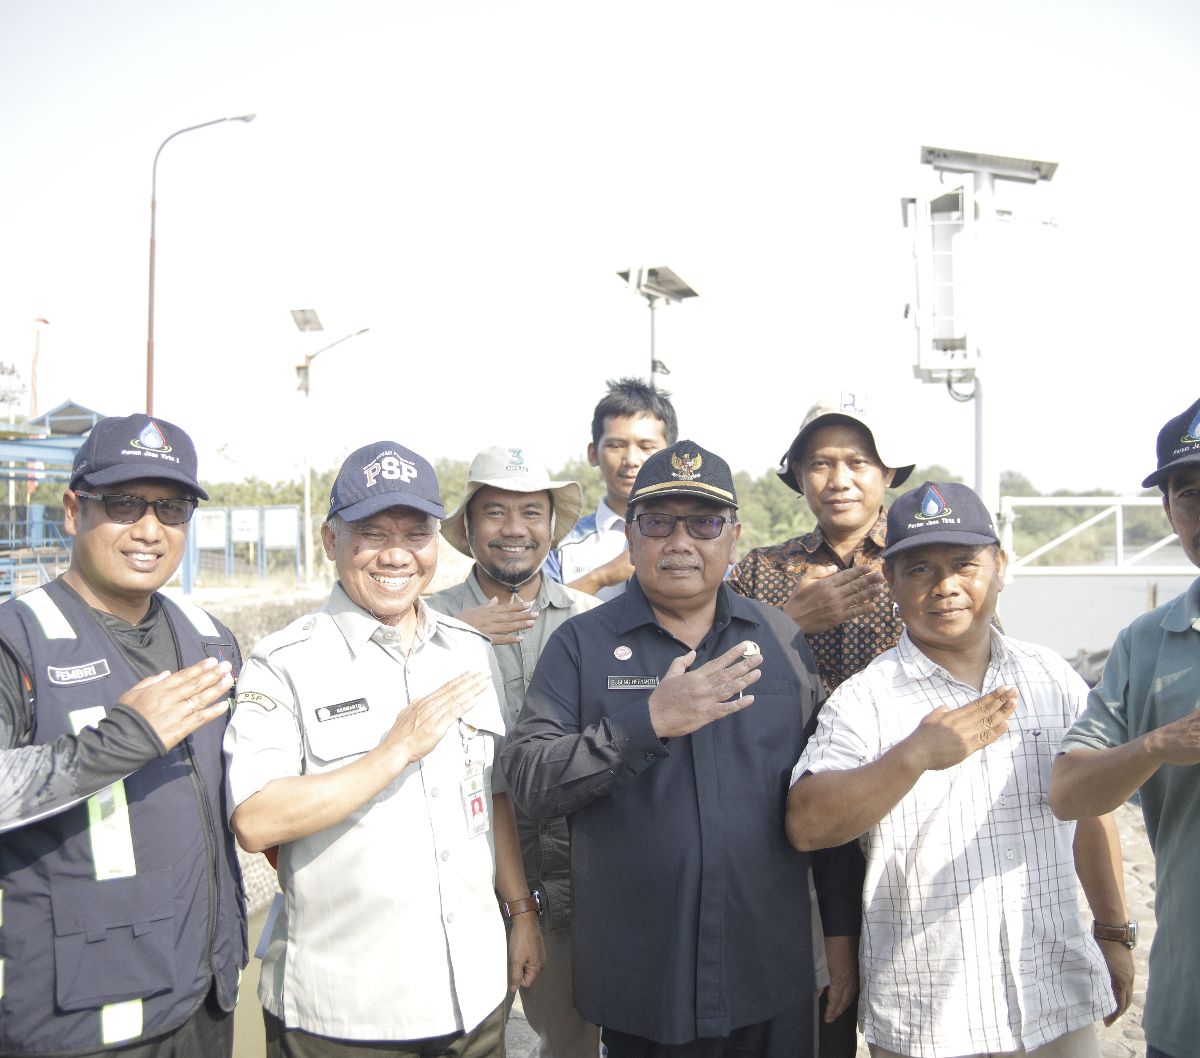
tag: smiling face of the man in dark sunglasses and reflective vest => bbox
[62,480,192,624]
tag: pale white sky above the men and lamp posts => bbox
[0,0,1200,492]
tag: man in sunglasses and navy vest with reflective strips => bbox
[0,415,246,1058]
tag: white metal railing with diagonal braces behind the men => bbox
[1000,495,1195,577]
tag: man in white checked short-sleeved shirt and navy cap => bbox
[787,481,1133,1058]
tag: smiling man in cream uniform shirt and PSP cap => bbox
[226,441,542,1058]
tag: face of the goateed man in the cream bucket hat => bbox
[467,485,553,589]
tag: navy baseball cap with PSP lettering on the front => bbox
[326,441,446,522]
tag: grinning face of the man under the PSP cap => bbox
[320,507,438,625]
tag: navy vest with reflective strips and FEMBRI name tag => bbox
[0,582,246,1054]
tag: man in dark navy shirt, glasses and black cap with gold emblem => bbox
[504,440,862,1058]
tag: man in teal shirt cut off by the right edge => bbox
[1050,401,1200,1058]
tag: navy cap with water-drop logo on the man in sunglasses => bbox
[68,414,209,499]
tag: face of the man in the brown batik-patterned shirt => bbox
[792,423,895,545]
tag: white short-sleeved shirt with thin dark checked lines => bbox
[792,630,1116,1058]
